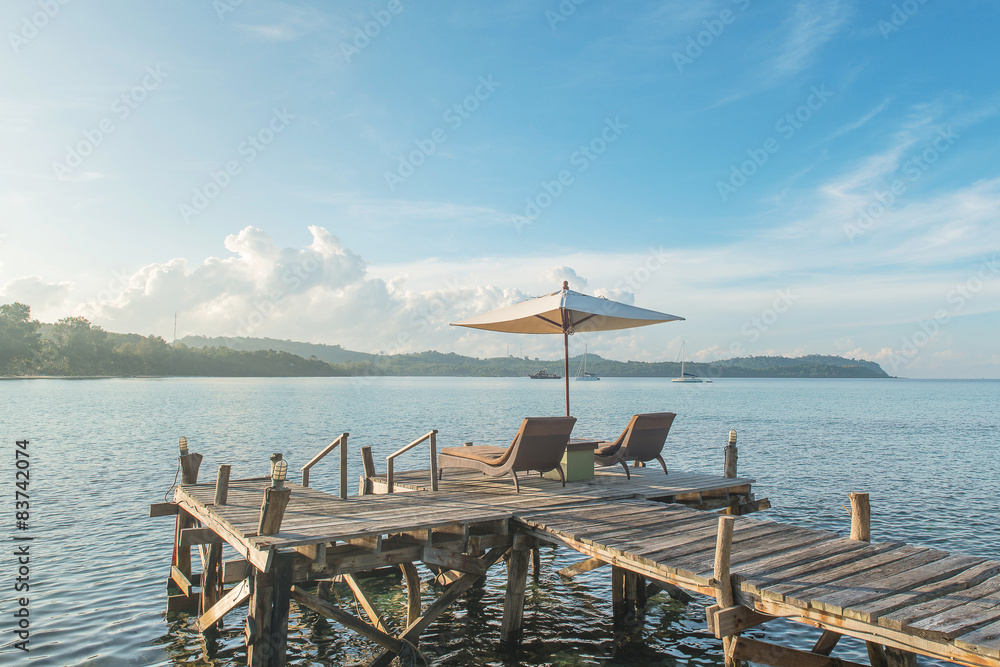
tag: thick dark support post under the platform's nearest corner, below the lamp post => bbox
[247,554,293,667]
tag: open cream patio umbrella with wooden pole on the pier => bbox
[451,281,684,416]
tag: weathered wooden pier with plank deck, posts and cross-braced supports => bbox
[150,434,1000,667]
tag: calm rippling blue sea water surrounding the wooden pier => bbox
[0,378,1000,667]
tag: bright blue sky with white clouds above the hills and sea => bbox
[0,0,1000,378]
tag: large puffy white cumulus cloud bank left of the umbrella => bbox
[78,226,526,353]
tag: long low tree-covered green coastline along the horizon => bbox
[0,303,890,379]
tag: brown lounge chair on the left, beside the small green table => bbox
[438,417,576,493]
